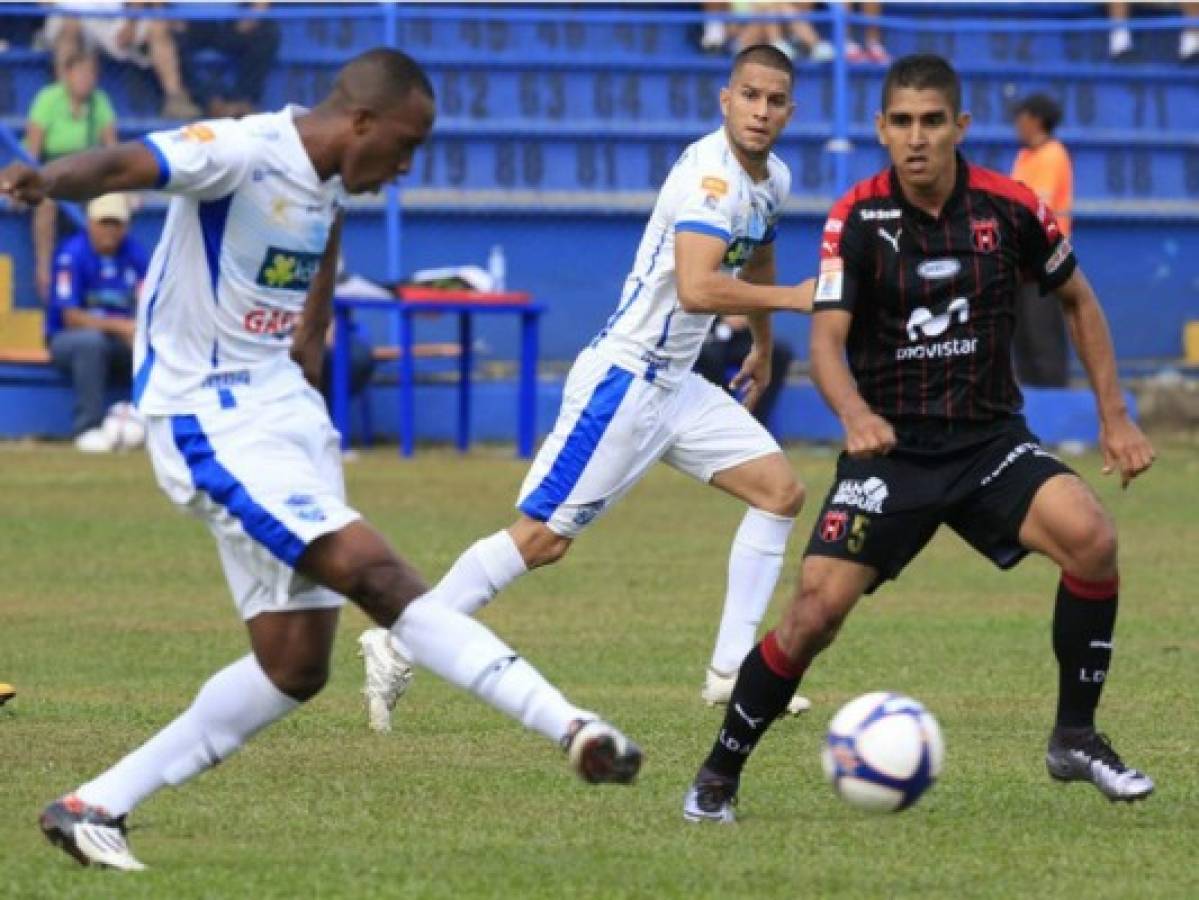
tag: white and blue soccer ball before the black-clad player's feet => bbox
[821,690,945,813]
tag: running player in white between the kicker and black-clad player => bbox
[360,46,813,731]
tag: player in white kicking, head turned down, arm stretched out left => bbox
[0,49,640,869]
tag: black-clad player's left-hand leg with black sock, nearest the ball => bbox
[683,556,878,822]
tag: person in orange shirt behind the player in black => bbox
[1012,93,1074,387]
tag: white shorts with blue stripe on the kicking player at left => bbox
[146,388,360,620]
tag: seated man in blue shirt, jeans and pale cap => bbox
[46,194,149,453]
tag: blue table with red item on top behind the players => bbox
[332,288,544,459]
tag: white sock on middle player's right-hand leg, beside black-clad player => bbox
[711,507,795,675]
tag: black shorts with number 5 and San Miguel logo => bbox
[805,417,1073,593]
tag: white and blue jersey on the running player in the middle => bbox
[591,126,791,387]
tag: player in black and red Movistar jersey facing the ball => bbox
[683,55,1153,822]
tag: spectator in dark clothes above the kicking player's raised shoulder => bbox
[175,2,279,117]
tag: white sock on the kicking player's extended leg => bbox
[392,596,596,742]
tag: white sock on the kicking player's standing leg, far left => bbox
[76,653,300,816]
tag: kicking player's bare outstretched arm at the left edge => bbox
[0,141,161,206]
